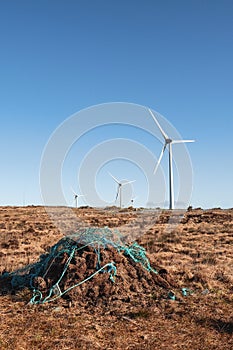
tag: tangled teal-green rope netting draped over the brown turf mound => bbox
[7,227,158,304]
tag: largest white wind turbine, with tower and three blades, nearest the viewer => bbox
[149,109,195,209]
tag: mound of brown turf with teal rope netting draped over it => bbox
[0,228,174,306]
